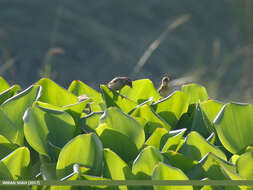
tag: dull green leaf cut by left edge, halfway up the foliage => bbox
[0,108,18,143]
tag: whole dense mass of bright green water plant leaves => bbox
[0,78,253,190]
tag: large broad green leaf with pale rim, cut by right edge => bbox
[214,103,253,154]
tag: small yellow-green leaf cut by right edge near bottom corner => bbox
[236,152,253,180]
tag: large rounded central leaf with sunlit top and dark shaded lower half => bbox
[96,107,145,161]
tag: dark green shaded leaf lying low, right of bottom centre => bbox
[162,150,198,172]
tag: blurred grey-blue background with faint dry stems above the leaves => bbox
[0,0,253,103]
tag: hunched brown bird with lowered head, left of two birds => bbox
[107,77,132,91]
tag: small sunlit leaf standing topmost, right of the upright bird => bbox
[182,83,208,104]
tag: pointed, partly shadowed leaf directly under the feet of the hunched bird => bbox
[100,85,138,113]
